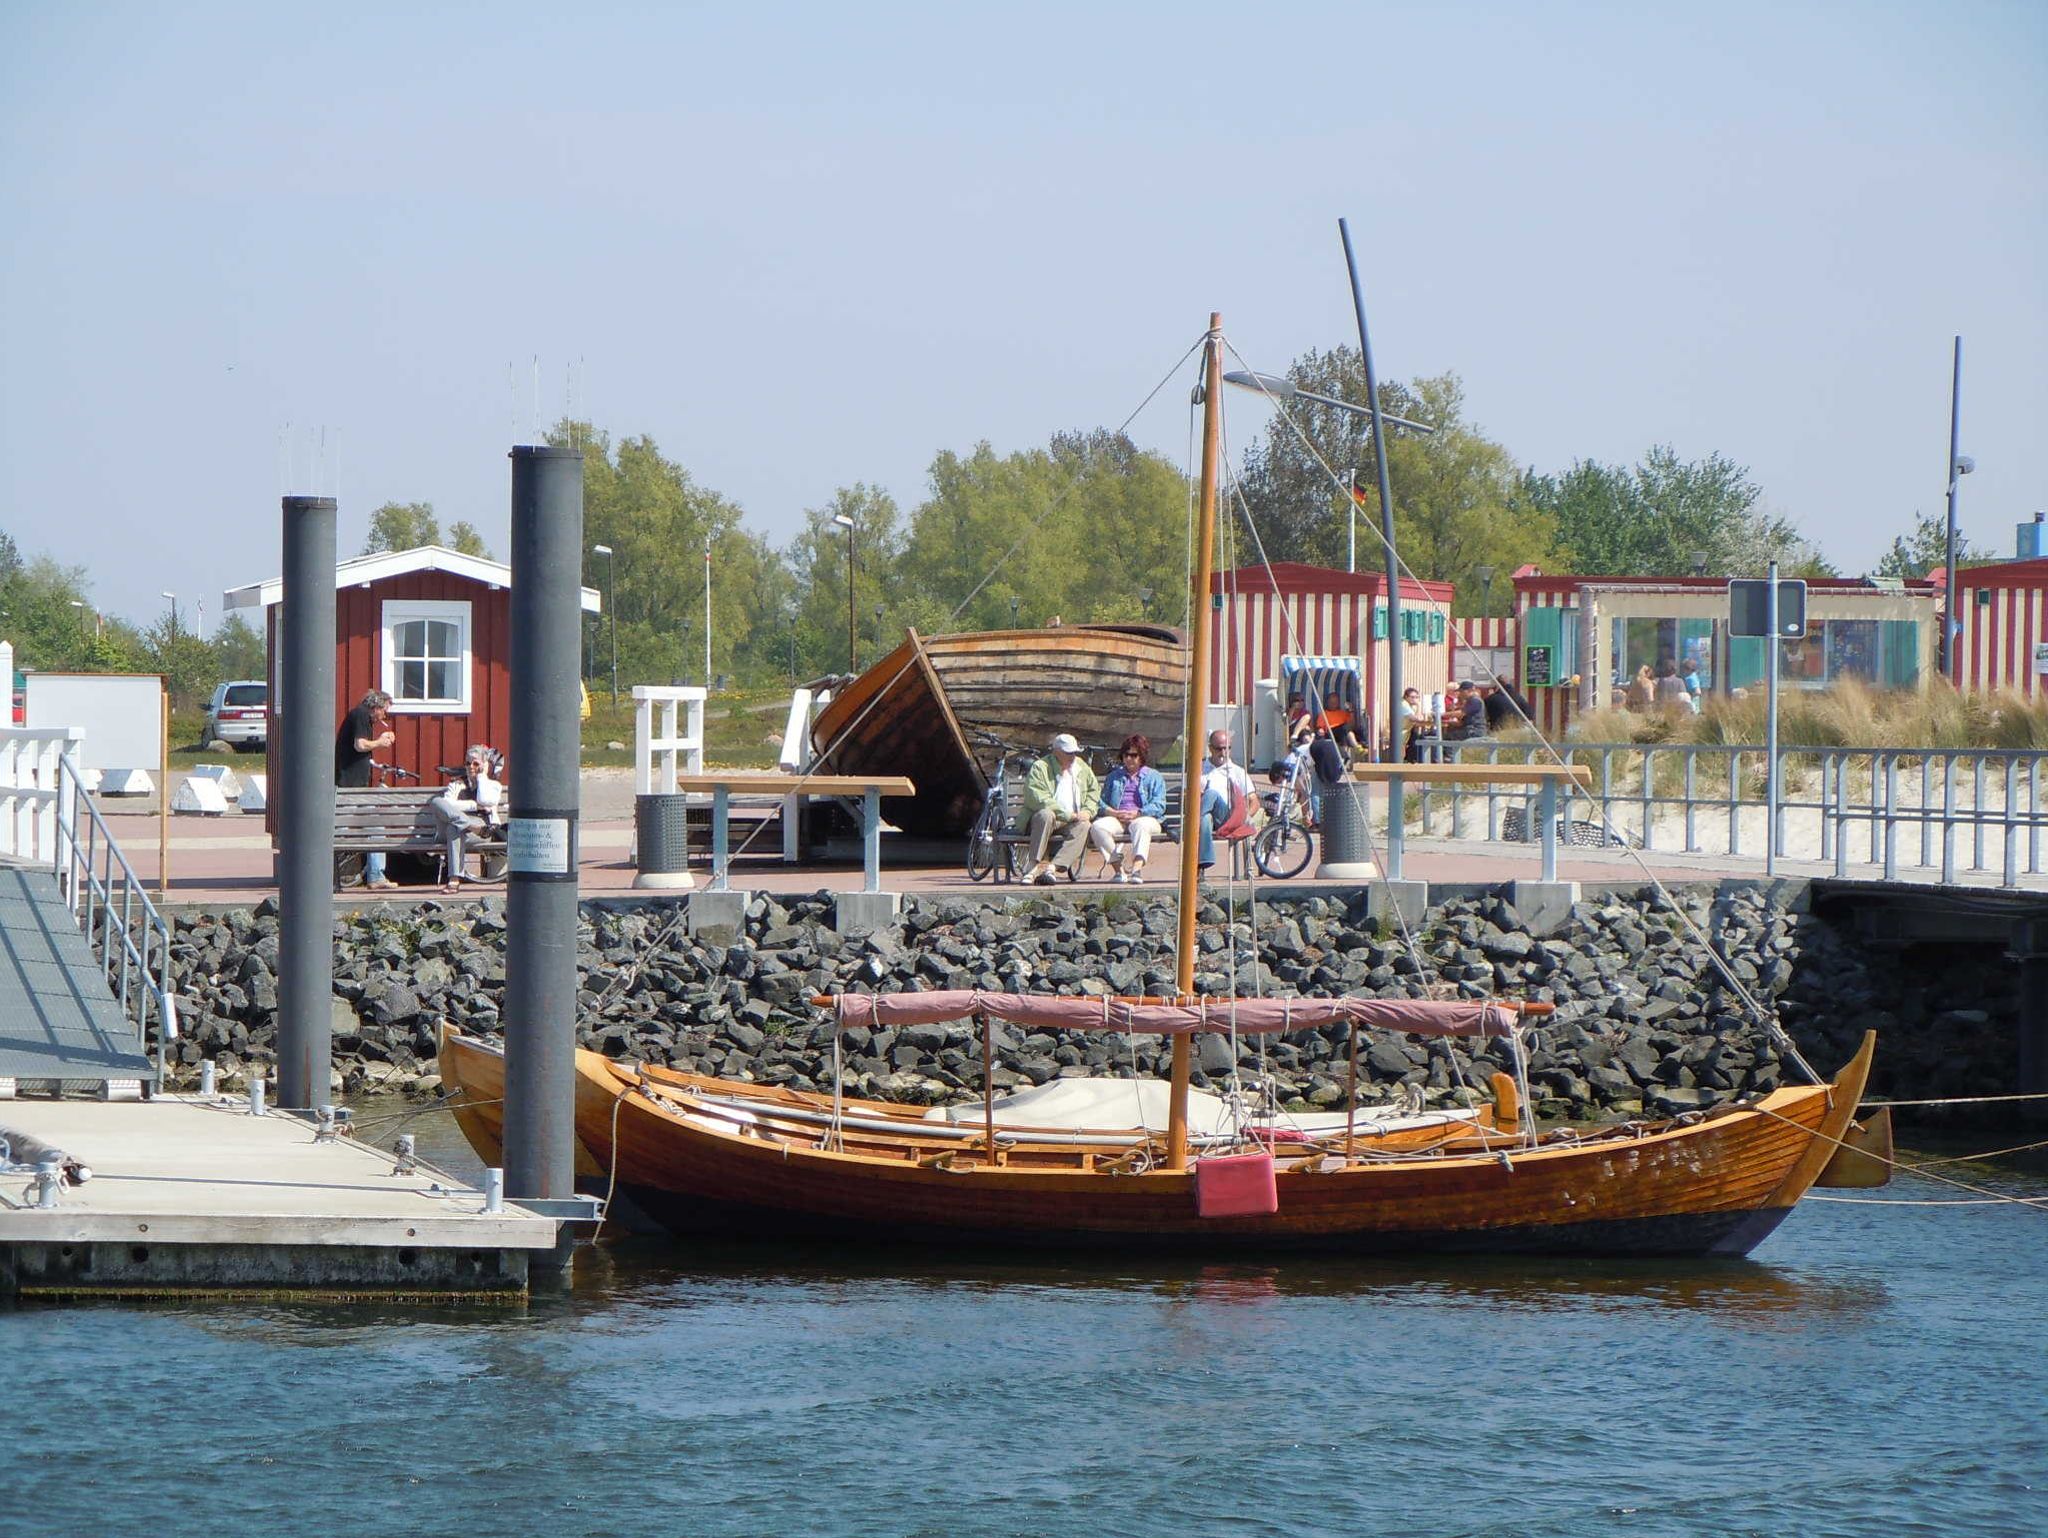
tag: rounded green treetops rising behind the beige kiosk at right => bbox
[1522,454,1825,578]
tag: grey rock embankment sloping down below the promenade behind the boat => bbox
[172,885,2015,1120]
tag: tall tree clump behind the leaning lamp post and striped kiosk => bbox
[1239,346,1552,612]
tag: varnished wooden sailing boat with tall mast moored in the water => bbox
[440,317,1876,1255]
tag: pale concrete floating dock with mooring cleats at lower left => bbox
[0,1096,559,1298]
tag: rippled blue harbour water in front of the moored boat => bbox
[0,1097,2048,1538]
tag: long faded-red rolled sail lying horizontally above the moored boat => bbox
[831,989,1516,1036]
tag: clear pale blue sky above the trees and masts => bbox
[0,0,2048,629]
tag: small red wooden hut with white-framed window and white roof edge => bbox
[223,545,598,834]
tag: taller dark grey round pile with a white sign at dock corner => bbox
[504,444,584,1270]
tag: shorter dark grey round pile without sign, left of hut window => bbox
[276,496,336,1110]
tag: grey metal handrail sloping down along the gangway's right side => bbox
[55,754,178,1090]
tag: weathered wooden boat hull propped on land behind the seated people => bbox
[811,625,1188,836]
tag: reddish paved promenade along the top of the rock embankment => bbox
[102,770,2048,907]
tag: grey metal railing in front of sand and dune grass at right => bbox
[1417,741,2048,887]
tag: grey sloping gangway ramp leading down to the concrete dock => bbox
[0,866,154,1085]
